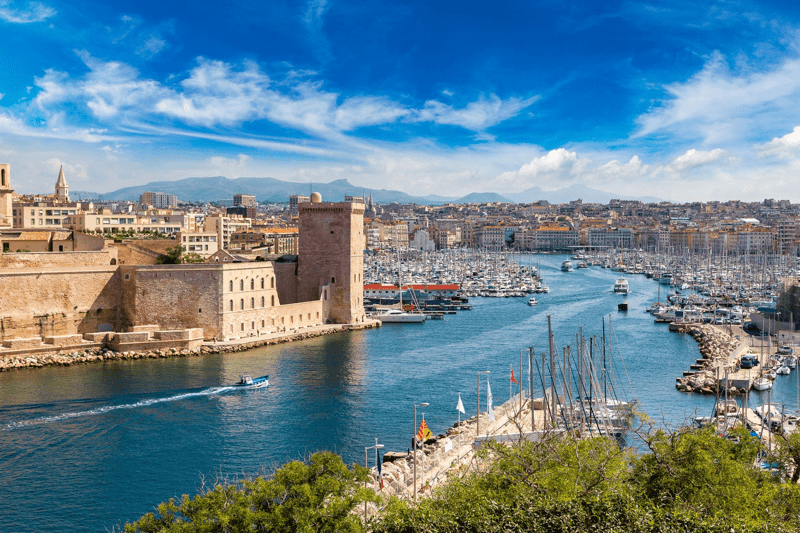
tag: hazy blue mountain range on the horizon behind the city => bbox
[71,176,662,205]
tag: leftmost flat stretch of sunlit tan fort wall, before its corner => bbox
[0,266,121,339]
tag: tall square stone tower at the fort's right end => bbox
[297,193,365,324]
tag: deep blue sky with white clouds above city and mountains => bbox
[0,0,800,202]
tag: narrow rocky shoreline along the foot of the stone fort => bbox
[0,321,380,372]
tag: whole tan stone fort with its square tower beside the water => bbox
[0,165,366,350]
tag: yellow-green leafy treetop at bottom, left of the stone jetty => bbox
[124,452,377,533]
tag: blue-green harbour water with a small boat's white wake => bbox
[0,256,796,532]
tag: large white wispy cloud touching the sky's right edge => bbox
[635,52,800,144]
